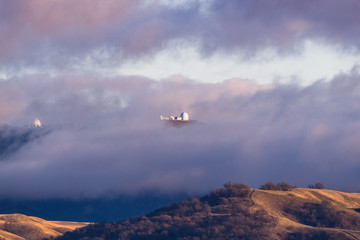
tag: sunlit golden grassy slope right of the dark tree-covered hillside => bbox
[252,188,360,239]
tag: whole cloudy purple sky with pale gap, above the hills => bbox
[0,0,360,199]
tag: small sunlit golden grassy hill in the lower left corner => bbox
[0,214,87,240]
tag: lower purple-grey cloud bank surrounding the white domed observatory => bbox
[0,67,360,198]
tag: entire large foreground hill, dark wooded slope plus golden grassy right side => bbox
[58,184,360,240]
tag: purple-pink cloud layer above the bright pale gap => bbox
[0,0,360,70]
